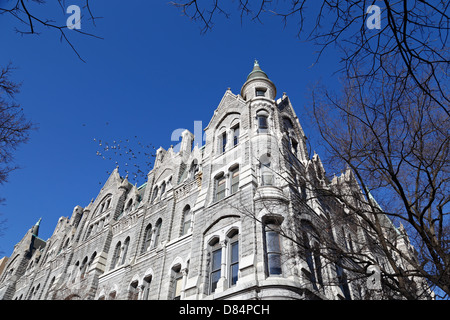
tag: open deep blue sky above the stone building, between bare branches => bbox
[0,1,339,255]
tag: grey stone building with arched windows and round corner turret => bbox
[0,62,428,300]
